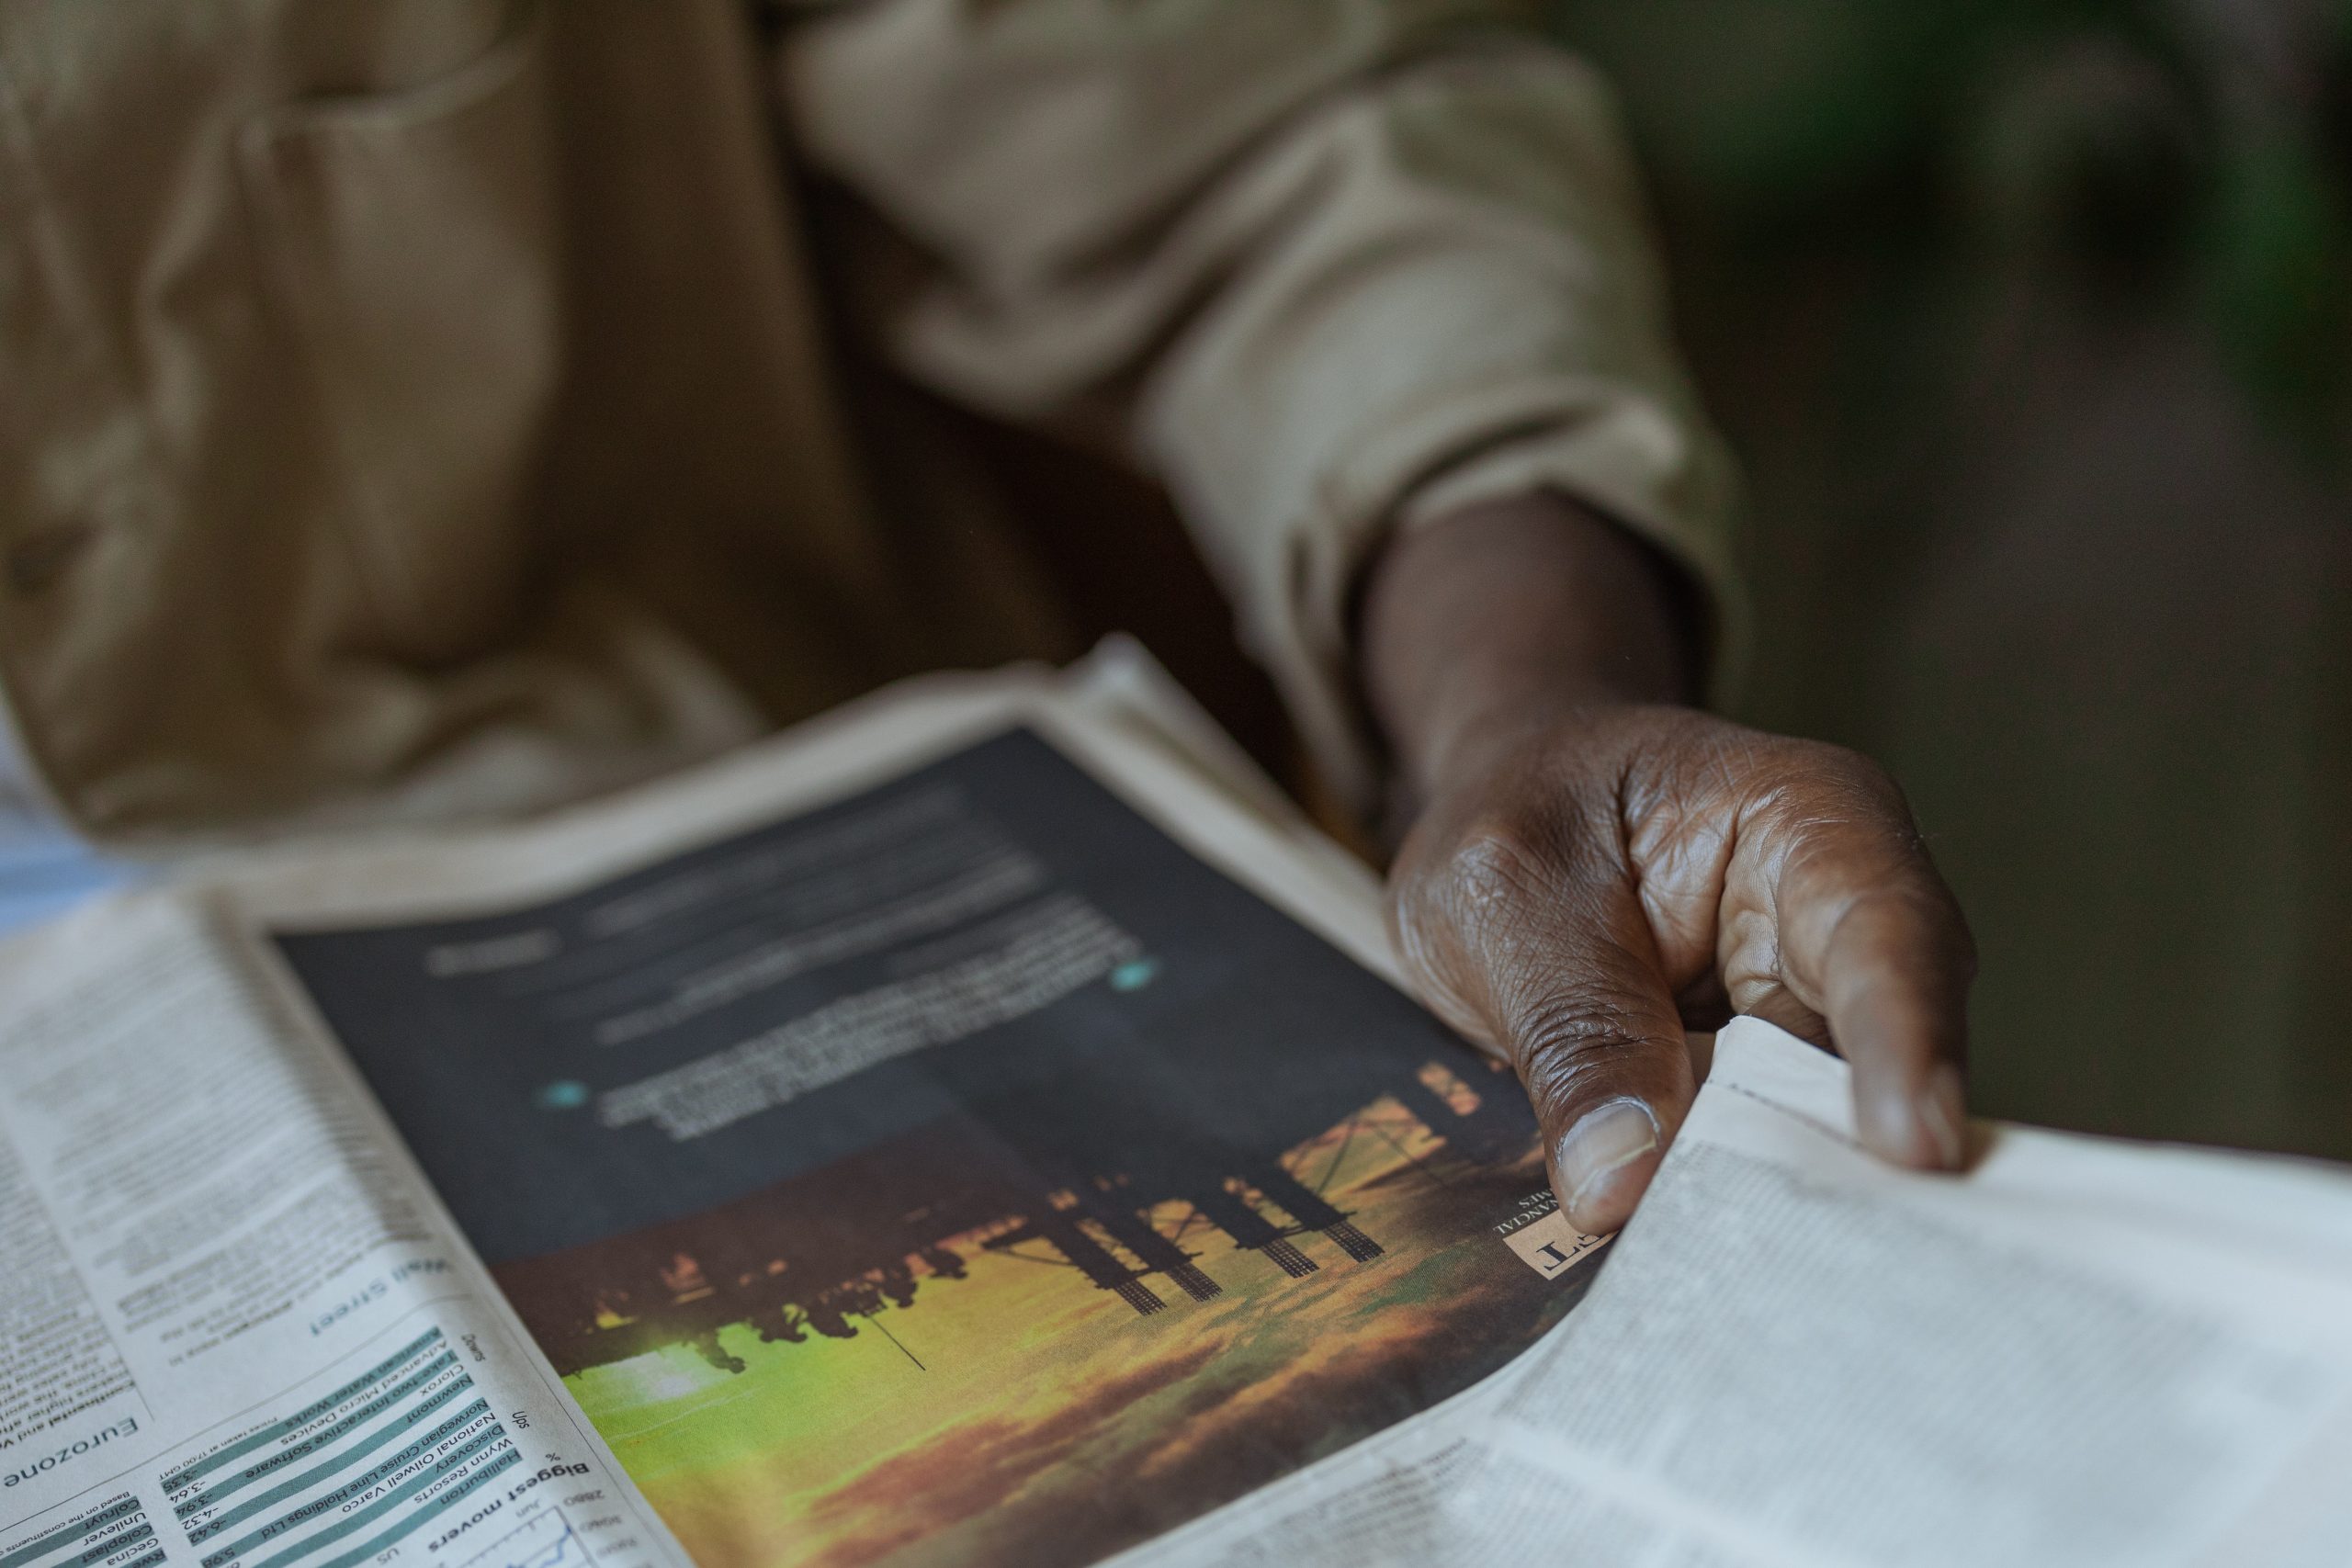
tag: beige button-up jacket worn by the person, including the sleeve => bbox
[0,0,1729,841]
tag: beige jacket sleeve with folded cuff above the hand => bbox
[783,0,1738,802]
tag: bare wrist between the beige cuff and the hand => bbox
[1360,493,1698,799]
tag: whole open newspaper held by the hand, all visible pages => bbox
[0,649,2352,1568]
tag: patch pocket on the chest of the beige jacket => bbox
[238,5,562,660]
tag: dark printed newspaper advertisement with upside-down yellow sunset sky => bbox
[266,728,1601,1568]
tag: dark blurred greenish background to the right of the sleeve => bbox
[1555,0,2352,1159]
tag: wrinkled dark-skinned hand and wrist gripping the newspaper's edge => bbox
[1364,496,1975,1235]
